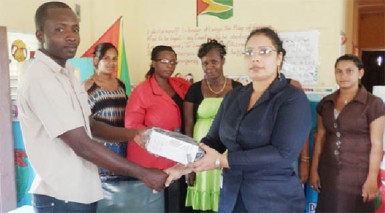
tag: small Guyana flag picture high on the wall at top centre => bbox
[197,0,233,19]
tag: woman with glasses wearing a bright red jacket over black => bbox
[125,46,190,212]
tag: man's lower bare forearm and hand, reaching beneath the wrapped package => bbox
[59,127,167,191]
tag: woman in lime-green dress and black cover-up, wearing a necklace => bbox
[183,39,242,211]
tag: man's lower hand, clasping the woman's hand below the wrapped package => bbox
[140,168,167,192]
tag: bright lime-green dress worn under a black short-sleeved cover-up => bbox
[186,98,223,211]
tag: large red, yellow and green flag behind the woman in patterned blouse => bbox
[82,17,131,96]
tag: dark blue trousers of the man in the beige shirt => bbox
[32,194,97,213]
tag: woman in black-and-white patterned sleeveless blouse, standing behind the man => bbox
[84,43,129,212]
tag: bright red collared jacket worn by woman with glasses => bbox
[125,76,190,169]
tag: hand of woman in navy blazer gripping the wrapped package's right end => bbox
[193,143,221,172]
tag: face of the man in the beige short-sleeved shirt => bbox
[36,8,80,65]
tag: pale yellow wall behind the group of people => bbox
[0,0,353,86]
